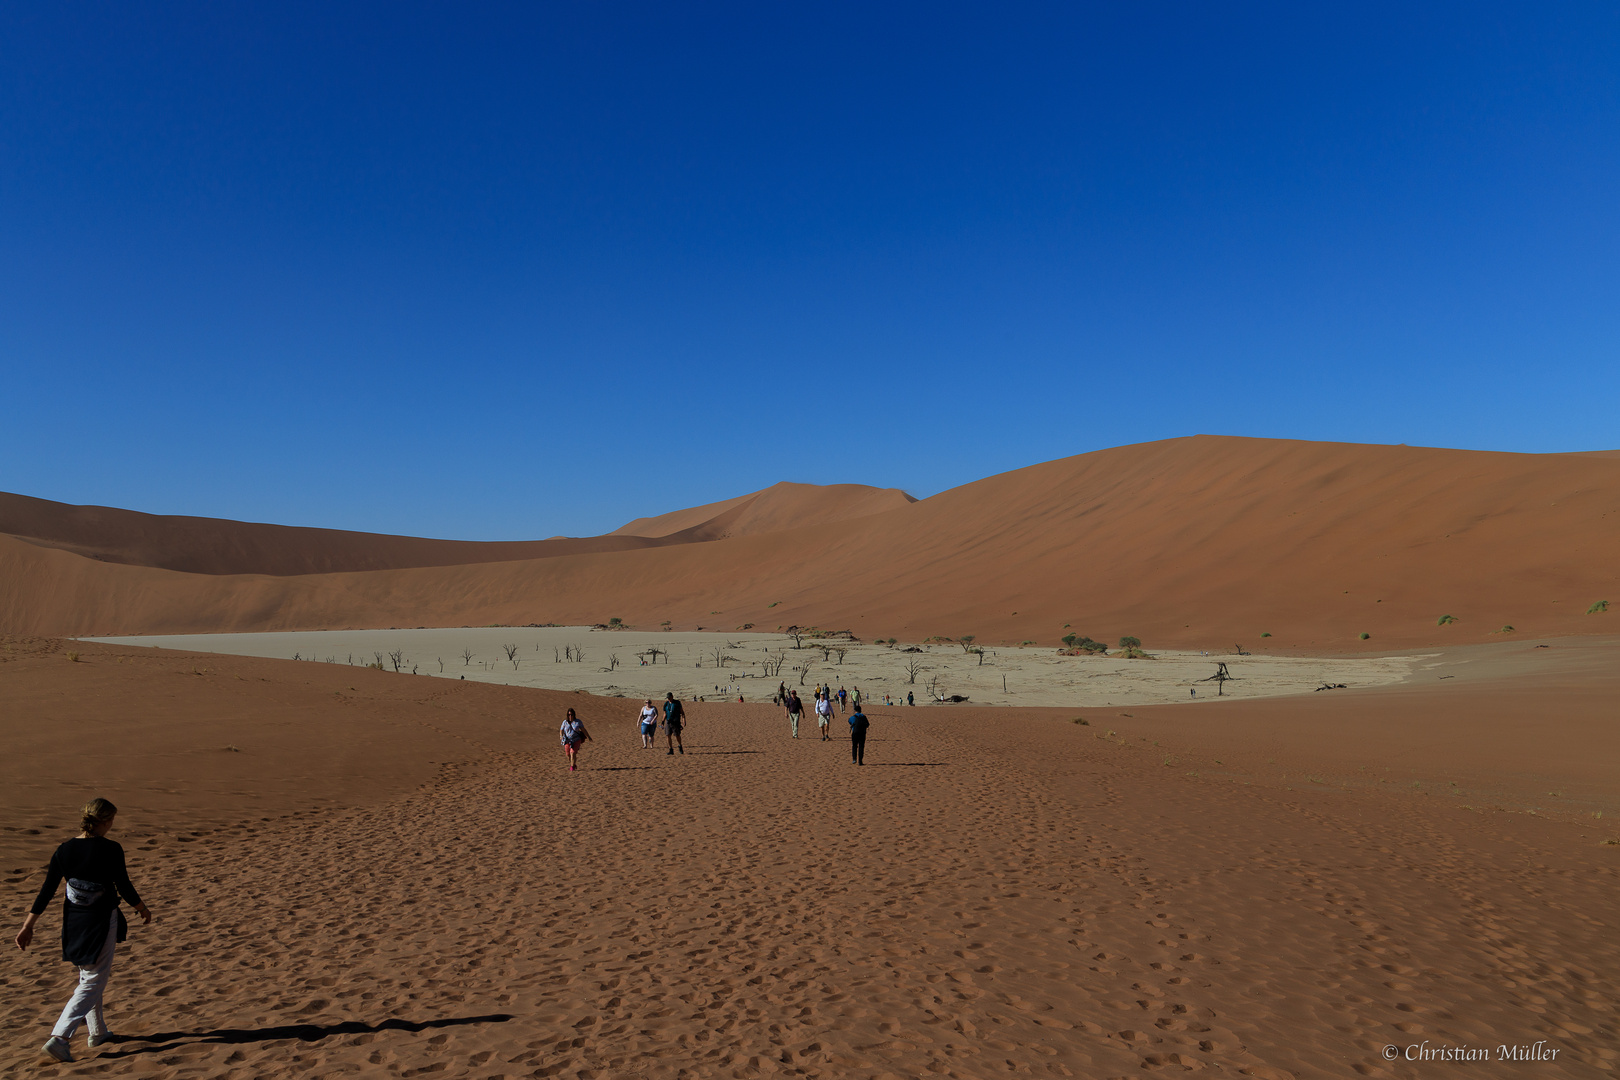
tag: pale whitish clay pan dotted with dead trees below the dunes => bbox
[82,627,1435,708]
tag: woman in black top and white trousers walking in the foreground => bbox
[16,798,152,1062]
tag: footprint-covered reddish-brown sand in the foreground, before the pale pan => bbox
[0,638,1620,1080]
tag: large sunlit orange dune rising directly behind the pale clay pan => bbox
[0,436,1620,651]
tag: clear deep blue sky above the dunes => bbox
[0,2,1620,539]
